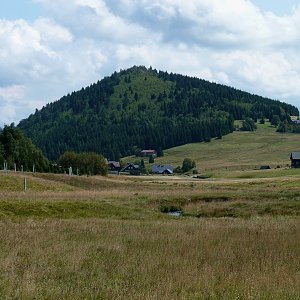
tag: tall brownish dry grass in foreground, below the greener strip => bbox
[0,218,300,299]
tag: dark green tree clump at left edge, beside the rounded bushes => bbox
[0,124,50,172]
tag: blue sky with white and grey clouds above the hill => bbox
[0,0,300,126]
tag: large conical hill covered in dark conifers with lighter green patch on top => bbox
[18,67,299,160]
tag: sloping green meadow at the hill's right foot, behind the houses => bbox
[124,122,300,173]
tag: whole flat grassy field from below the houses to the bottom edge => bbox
[0,168,300,299]
